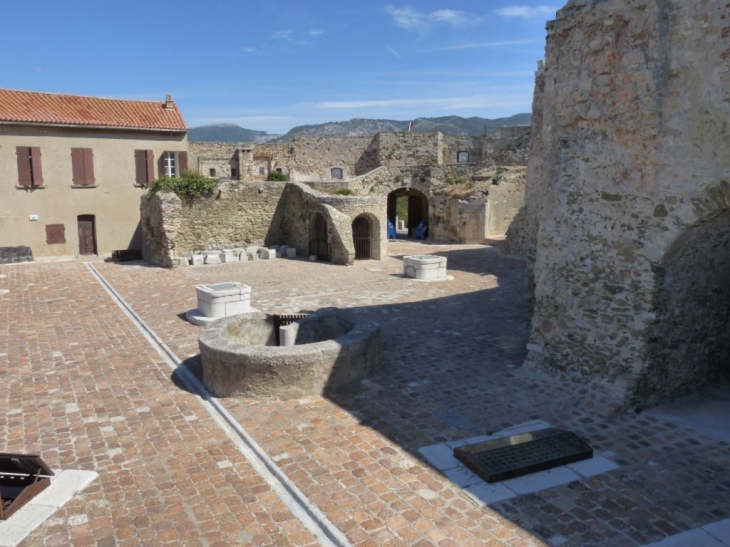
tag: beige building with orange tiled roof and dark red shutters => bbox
[0,89,188,262]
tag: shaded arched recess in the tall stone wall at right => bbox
[636,211,730,404]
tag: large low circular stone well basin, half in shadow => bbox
[198,309,381,400]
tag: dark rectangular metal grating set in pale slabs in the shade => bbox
[454,427,593,482]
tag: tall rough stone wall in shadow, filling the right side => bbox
[509,0,730,408]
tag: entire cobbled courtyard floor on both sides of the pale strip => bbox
[0,242,730,547]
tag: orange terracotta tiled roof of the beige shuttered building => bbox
[0,89,187,131]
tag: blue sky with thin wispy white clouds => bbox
[0,0,564,133]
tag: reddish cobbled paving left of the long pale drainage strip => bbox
[0,262,317,547]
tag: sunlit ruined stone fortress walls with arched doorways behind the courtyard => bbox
[141,130,529,267]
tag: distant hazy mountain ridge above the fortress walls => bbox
[188,114,532,142]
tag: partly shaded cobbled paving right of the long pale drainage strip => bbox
[92,242,730,547]
